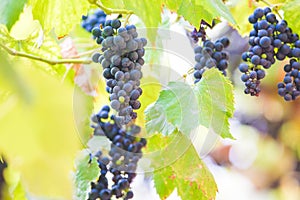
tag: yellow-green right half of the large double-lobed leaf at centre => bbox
[194,68,234,138]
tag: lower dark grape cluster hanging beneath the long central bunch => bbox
[88,106,147,200]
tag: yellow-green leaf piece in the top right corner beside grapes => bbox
[282,0,300,33]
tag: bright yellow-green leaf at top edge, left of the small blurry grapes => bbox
[29,0,89,36]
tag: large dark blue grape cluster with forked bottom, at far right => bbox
[239,7,300,100]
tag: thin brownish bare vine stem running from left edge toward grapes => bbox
[0,43,92,65]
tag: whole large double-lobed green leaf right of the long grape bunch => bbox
[145,69,234,138]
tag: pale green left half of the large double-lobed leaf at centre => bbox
[145,82,199,135]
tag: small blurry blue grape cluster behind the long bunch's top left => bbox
[81,9,106,32]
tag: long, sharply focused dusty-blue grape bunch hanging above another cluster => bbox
[92,19,147,125]
